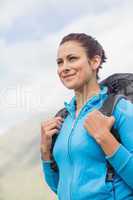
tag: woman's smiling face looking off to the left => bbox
[57,41,96,90]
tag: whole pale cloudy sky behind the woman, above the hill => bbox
[0,0,133,133]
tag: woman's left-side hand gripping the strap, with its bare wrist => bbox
[40,116,64,160]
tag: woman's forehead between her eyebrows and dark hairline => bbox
[57,41,85,58]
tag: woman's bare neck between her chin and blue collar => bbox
[75,79,100,114]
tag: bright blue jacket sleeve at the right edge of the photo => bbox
[106,99,133,189]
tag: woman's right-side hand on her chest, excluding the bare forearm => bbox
[84,110,115,143]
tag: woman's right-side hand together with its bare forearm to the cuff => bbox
[84,110,120,156]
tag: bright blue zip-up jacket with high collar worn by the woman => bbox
[42,86,133,200]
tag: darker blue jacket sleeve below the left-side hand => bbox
[41,160,59,194]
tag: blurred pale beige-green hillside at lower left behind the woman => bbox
[0,113,56,200]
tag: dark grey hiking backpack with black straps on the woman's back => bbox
[51,73,133,181]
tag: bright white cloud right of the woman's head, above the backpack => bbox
[55,1,133,78]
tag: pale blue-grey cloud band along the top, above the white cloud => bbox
[0,0,128,42]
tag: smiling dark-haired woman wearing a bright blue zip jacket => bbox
[41,33,133,200]
